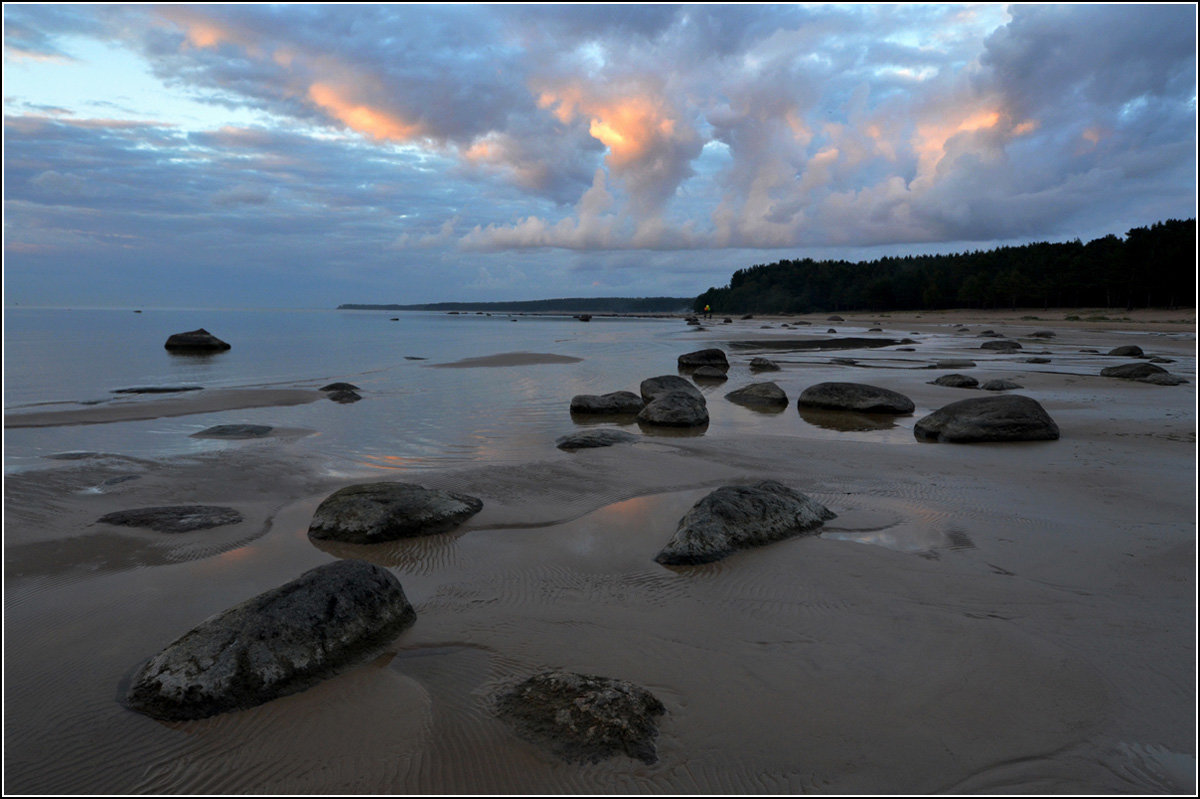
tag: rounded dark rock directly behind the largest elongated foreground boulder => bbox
[308,482,484,543]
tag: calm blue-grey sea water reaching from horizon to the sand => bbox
[4,308,820,471]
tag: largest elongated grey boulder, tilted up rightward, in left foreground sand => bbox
[127,560,416,721]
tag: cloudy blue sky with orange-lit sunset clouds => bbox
[4,4,1196,308]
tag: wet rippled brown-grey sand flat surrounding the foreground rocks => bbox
[5,314,1196,794]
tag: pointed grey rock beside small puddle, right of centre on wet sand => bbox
[654,480,836,565]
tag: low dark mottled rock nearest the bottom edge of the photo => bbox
[496,671,666,764]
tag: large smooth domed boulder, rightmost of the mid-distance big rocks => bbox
[913,394,1058,444]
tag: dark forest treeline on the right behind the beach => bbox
[692,218,1196,313]
